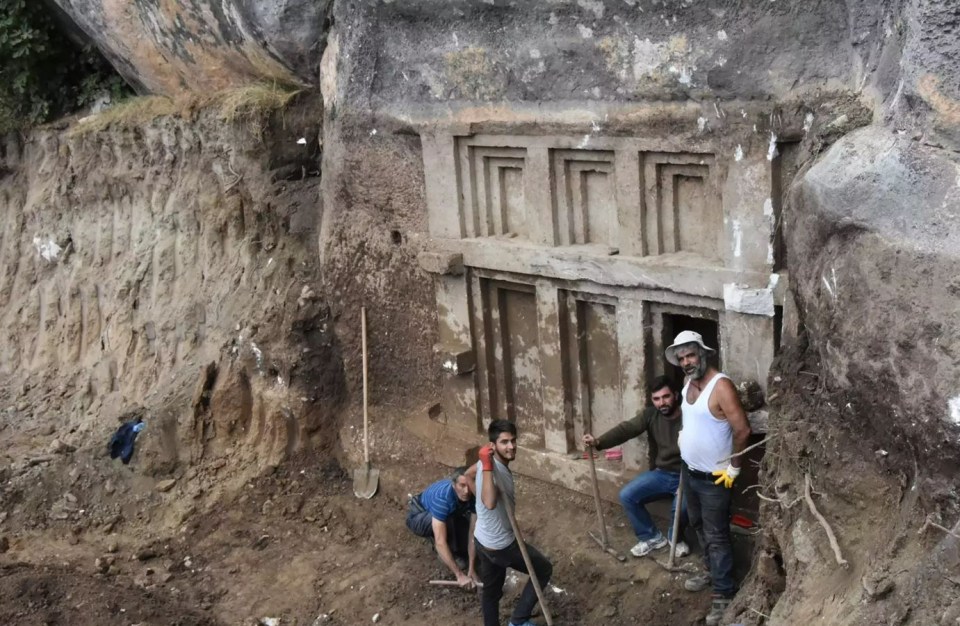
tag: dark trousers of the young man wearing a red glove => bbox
[476,540,553,626]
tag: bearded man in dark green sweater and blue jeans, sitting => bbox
[583,376,690,557]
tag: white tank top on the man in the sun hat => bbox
[679,373,733,472]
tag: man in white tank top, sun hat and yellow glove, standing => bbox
[666,330,750,626]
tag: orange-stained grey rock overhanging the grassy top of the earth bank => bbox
[55,0,330,95]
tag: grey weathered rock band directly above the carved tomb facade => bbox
[337,0,892,110]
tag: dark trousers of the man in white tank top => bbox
[683,467,737,598]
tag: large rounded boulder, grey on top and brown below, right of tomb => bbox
[790,128,960,454]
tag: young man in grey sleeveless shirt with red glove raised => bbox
[475,420,553,626]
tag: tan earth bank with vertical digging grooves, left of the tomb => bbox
[0,97,345,473]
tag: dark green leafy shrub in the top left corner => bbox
[0,0,129,131]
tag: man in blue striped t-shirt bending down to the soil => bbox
[407,467,478,588]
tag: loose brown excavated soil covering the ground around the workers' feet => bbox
[0,402,728,626]
